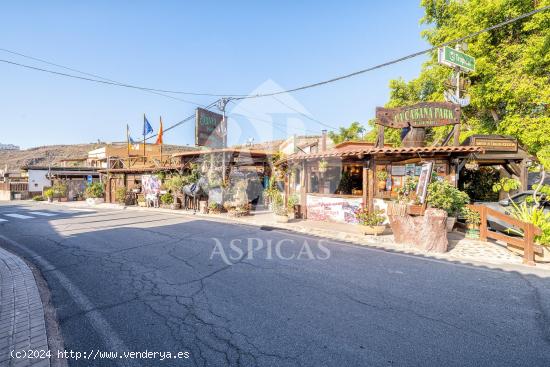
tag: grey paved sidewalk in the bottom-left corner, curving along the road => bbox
[0,248,50,367]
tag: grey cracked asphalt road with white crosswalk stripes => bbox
[0,203,550,367]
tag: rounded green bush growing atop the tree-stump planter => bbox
[427,180,470,216]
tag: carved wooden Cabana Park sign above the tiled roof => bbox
[376,102,460,129]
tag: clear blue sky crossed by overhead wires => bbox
[0,0,427,148]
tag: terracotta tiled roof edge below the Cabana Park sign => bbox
[287,144,483,160]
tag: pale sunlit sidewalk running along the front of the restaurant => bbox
[43,202,550,270]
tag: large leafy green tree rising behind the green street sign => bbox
[378,0,550,155]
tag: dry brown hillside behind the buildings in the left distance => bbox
[0,143,191,170]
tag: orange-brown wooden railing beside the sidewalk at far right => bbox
[468,205,543,265]
